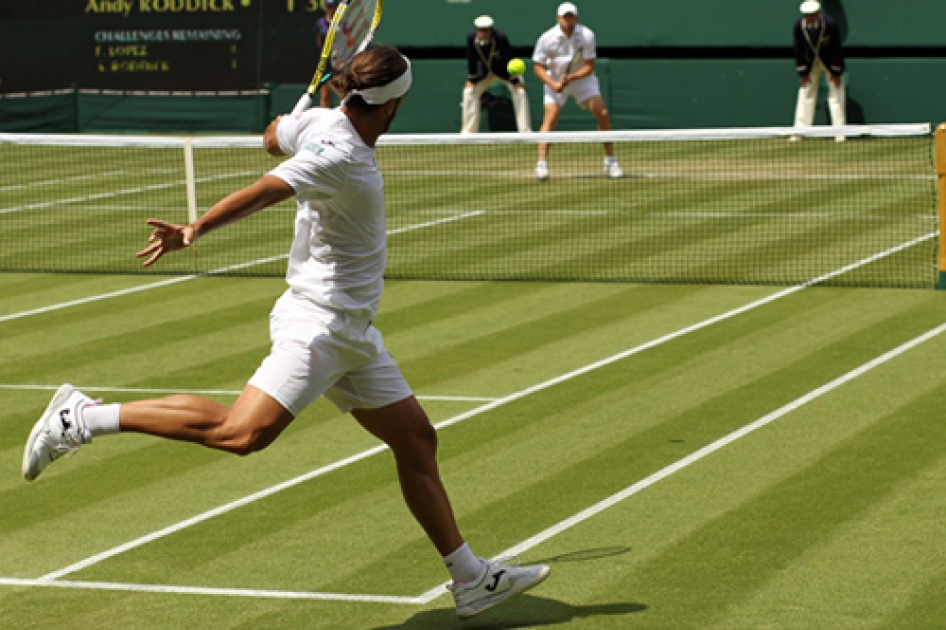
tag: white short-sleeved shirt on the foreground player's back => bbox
[270,108,387,318]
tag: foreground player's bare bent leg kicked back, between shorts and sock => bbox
[121,385,293,455]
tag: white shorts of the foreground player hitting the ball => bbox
[249,289,412,416]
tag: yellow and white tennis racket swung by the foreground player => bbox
[292,0,384,114]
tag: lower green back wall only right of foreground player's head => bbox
[386,59,946,133]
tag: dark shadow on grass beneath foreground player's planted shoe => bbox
[375,595,647,630]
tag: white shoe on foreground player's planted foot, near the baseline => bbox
[450,558,551,619]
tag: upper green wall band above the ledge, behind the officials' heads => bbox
[378,0,946,48]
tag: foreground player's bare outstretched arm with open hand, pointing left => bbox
[136,175,296,267]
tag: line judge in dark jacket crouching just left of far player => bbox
[461,15,532,133]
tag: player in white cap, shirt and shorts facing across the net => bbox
[532,2,624,180]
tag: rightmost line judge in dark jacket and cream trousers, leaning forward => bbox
[791,0,847,142]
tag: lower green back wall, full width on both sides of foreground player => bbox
[0,58,946,133]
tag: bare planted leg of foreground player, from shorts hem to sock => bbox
[351,396,463,556]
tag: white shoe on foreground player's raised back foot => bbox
[23,383,95,481]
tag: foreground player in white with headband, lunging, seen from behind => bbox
[23,47,549,617]
